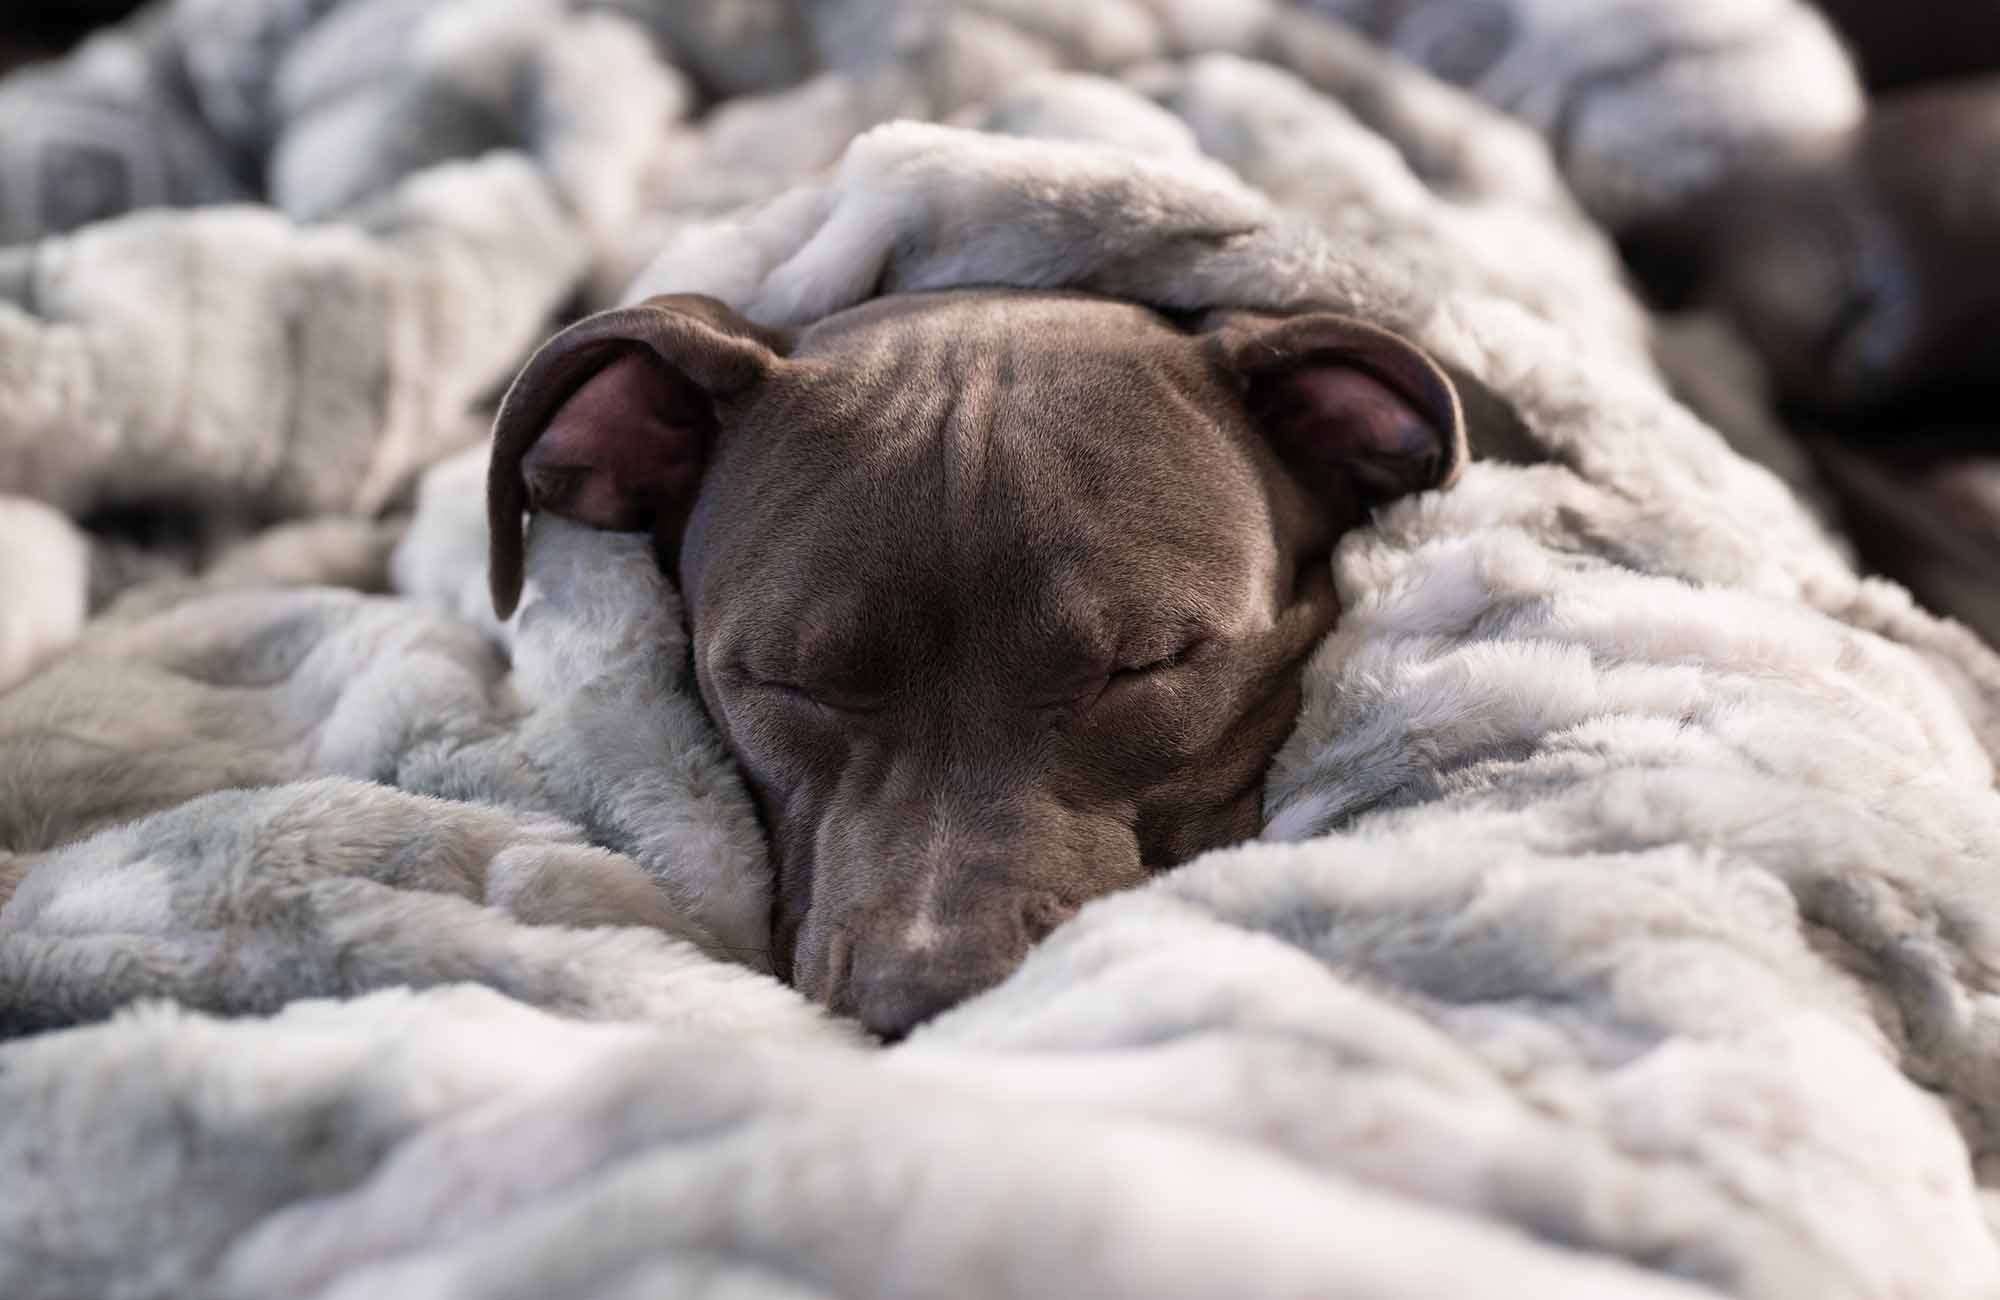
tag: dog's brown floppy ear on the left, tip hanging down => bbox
[486,294,786,618]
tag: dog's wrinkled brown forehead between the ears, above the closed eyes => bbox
[696,298,1274,652]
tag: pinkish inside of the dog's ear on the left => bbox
[522,352,706,532]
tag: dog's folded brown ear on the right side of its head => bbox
[1212,312,1468,520]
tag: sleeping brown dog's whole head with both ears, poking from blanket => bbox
[490,290,1464,1036]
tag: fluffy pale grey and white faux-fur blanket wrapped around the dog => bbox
[0,0,2000,1300]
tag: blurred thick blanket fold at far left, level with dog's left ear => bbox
[0,154,584,516]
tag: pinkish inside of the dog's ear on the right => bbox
[1266,358,1444,500]
